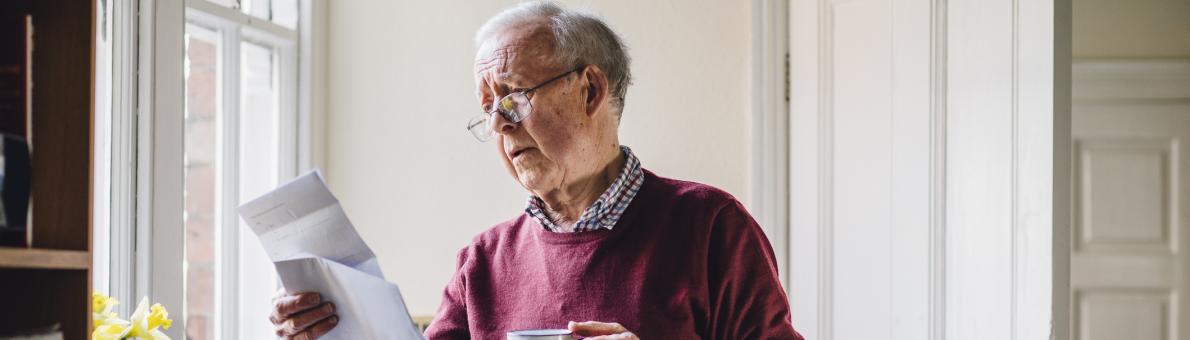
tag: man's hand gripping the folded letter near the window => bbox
[269,290,339,340]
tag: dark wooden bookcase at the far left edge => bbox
[0,0,95,339]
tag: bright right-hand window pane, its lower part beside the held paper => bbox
[239,43,281,339]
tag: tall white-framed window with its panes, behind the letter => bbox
[182,0,298,340]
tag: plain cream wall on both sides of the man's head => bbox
[325,0,752,315]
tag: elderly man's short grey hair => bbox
[475,1,632,114]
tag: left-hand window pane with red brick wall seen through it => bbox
[182,25,221,340]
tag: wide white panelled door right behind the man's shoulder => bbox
[789,0,1070,340]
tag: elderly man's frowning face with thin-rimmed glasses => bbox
[475,25,600,194]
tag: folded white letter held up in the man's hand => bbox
[238,170,424,340]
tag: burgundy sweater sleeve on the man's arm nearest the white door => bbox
[707,200,802,340]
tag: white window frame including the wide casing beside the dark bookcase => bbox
[93,0,325,339]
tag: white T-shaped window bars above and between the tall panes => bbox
[183,1,299,339]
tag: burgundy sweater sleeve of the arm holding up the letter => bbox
[425,246,471,340]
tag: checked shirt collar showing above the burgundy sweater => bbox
[525,145,645,233]
